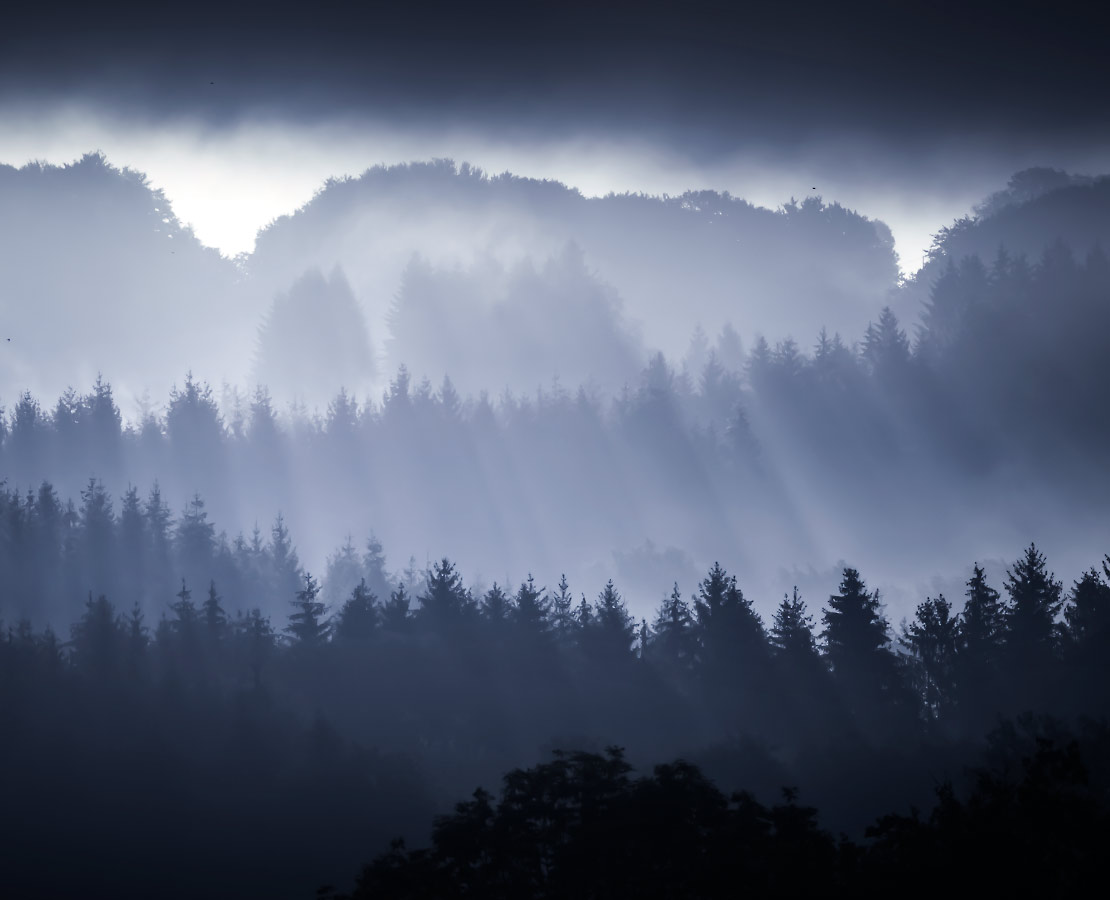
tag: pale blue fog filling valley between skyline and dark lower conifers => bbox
[0,149,1107,634]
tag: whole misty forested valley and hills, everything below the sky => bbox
[0,154,1110,898]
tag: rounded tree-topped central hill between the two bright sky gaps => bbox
[249,160,898,362]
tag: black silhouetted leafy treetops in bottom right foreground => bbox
[339,717,1110,900]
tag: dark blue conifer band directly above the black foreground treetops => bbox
[0,486,1110,894]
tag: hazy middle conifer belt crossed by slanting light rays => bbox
[0,239,1110,599]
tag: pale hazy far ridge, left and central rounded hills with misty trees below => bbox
[0,155,897,403]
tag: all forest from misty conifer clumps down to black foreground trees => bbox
[0,167,1110,898]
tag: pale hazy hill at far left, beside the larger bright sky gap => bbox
[0,154,245,401]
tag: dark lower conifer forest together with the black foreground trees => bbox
[0,499,1110,897]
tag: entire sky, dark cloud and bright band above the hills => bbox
[0,2,1110,272]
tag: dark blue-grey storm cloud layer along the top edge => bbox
[0,2,1110,153]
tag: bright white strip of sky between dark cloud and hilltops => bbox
[0,110,1092,274]
